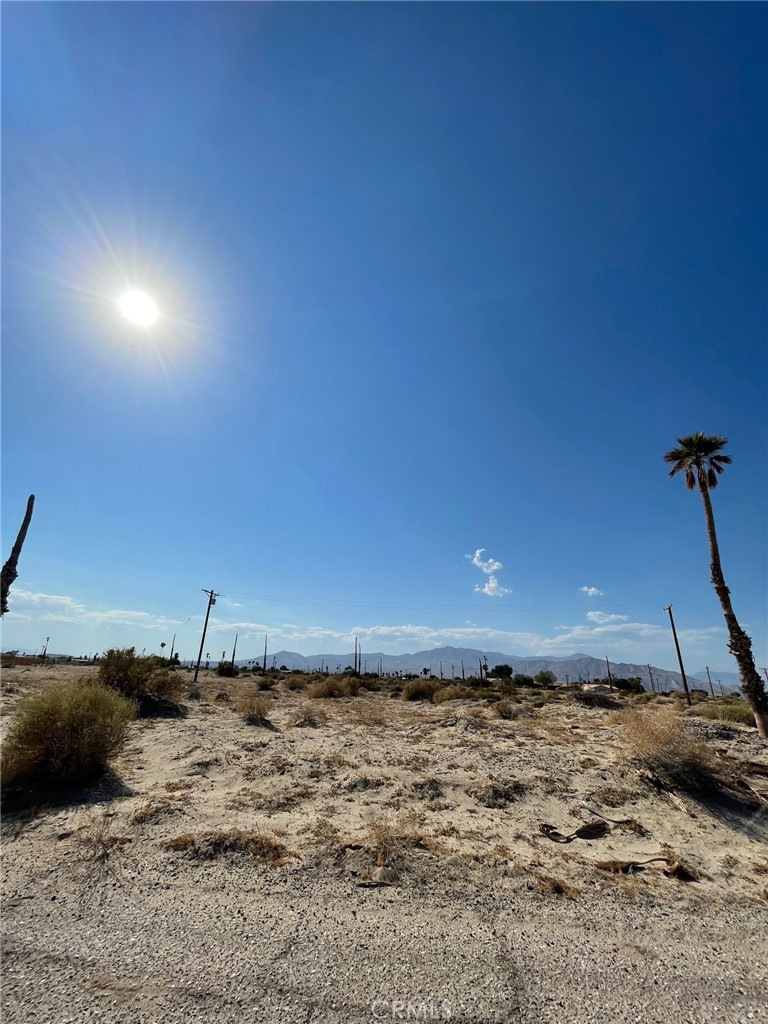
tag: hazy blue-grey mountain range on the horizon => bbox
[238,647,716,690]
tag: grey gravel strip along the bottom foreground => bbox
[3,861,768,1024]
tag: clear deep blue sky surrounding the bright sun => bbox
[2,3,768,671]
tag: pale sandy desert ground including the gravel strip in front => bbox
[0,667,768,1024]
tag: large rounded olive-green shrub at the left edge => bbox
[2,682,136,785]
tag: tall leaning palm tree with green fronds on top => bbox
[664,432,768,739]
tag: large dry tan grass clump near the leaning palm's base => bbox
[620,709,727,793]
